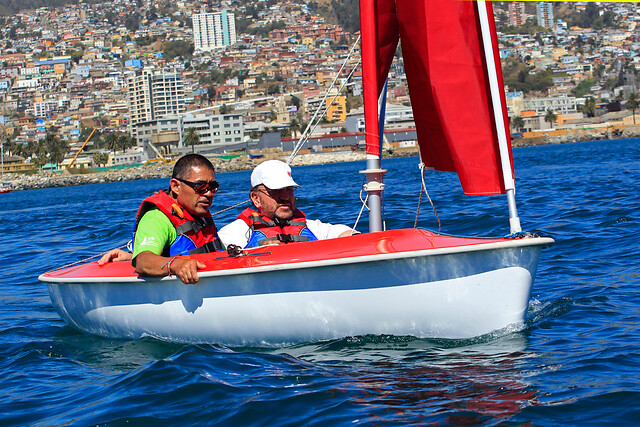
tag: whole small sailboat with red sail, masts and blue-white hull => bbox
[40,0,553,346]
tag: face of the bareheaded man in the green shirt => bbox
[170,166,216,216]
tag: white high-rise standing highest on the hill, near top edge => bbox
[191,10,236,51]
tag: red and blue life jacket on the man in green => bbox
[133,190,224,256]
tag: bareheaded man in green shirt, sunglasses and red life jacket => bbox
[99,154,223,283]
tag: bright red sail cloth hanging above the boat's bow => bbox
[360,0,513,195]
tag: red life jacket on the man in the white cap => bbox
[238,208,318,248]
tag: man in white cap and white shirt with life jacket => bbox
[218,160,352,248]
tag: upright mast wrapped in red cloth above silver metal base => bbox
[360,0,386,232]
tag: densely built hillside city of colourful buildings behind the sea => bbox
[0,0,640,172]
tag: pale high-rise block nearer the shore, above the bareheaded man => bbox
[127,68,186,129]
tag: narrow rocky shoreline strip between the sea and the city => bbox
[3,134,638,191]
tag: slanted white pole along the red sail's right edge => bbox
[476,0,522,234]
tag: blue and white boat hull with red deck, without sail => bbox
[41,230,553,346]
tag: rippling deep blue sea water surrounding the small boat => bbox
[0,139,640,426]
